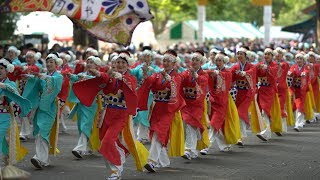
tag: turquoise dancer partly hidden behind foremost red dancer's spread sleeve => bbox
[69,56,102,158]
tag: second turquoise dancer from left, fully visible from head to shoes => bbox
[29,53,63,169]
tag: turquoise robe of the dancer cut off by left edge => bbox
[0,78,31,155]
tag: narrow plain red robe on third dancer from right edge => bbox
[277,61,290,118]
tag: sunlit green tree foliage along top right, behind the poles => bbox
[148,0,315,35]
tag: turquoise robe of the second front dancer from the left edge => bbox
[33,71,63,143]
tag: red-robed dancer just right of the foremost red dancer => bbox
[138,50,185,172]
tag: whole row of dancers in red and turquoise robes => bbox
[0,44,319,179]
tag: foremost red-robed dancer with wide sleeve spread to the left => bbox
[73,51,137,180]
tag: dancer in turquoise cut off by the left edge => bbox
[0,59,31,168]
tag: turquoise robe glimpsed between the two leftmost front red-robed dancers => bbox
[130,64,161,127]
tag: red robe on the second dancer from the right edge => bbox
[290,64,309,113]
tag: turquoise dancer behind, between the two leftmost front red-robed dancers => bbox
[131,50,161,143]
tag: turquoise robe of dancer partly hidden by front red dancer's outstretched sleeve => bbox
[68,72,98,138]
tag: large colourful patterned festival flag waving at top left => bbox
[0,0,153,45]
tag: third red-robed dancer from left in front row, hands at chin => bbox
[181,51,208,160]
